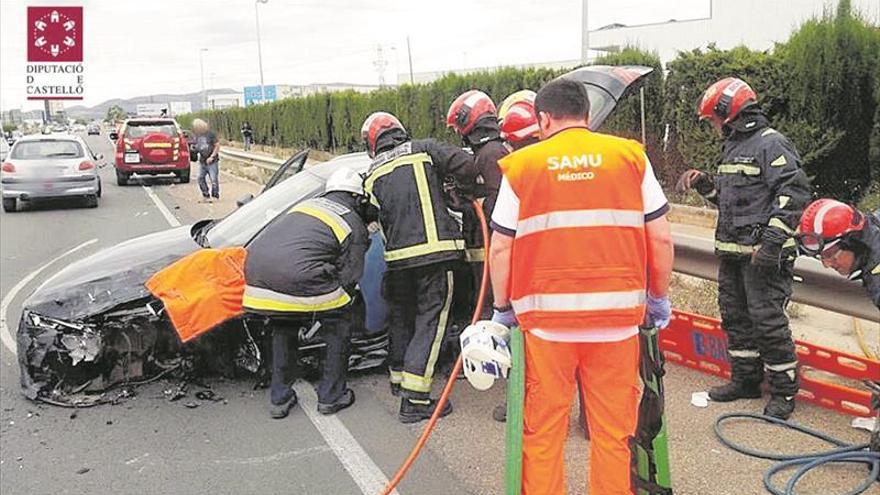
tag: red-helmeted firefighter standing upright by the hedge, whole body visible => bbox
[678,77,810,419]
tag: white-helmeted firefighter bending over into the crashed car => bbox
[242,169,376,419]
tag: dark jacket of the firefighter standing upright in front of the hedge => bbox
[704,113,810,257]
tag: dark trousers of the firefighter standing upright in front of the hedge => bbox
[718,257,798,397]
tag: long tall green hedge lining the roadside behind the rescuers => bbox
[180,0,880,201]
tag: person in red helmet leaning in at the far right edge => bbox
[797,199,880,308]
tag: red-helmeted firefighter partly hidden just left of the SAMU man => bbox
[446,89,509,319]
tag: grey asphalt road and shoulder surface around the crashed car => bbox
[0,136,880,495]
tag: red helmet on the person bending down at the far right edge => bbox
[797,199,865,256]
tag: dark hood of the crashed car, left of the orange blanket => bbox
[24,226,199,321]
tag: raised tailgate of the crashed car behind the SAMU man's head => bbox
[560,65,654,131]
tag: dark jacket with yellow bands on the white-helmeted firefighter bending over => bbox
[243,192,369,313]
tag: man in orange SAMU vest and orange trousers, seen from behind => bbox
[490,78,673,495]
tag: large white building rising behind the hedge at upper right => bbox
[590,0,880,64]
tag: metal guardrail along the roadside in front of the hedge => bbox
[220,148,880,322]
